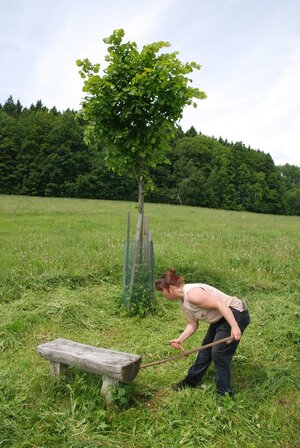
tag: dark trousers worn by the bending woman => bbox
[187,308,250,396]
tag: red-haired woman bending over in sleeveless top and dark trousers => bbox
[155,269,250,397]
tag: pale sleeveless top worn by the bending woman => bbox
[181,283,244,324]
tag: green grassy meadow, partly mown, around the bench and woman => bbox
[0,196,300,448]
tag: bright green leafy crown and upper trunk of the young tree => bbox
[77,29,205,306]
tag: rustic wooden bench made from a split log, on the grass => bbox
[37,339,142,405]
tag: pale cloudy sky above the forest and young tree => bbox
[0,0,300,166]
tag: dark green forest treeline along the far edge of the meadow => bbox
[0,97,300,215]
